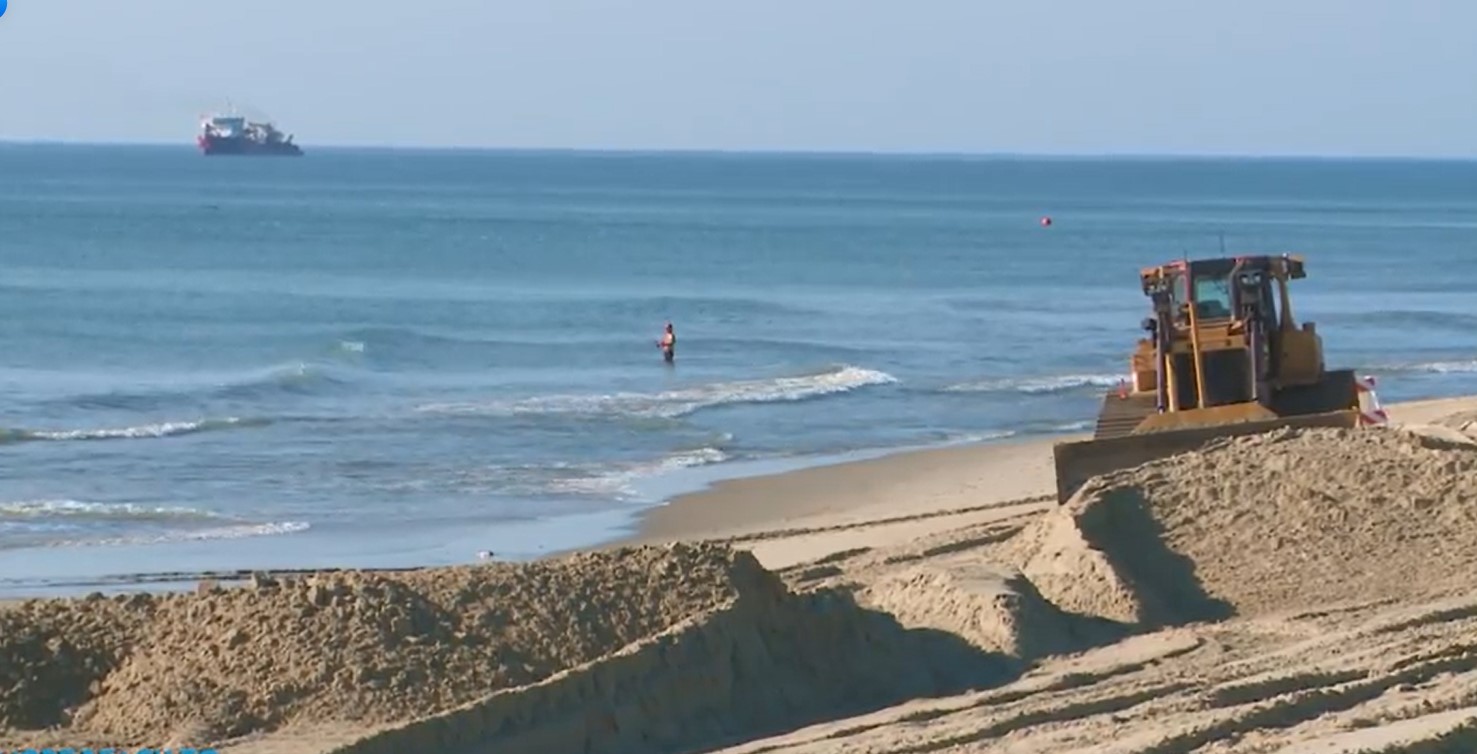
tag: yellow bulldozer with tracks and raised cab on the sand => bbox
[1053,254,1363,504]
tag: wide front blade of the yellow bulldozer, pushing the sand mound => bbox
[1052,410,1359,504]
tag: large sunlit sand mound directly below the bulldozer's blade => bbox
[1004,429,1477,625]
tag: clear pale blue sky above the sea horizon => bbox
[0,0,1477,157]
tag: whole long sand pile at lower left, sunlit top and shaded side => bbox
[0,544,1010,753]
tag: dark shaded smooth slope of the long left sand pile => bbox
[319,570,1016,754]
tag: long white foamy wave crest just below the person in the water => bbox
[419,365,898,418]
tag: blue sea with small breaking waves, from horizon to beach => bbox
[0,145,1477,590]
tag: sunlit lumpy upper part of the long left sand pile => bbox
[0,546,783,744]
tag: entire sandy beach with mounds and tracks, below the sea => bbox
[0,399,1477,754]
